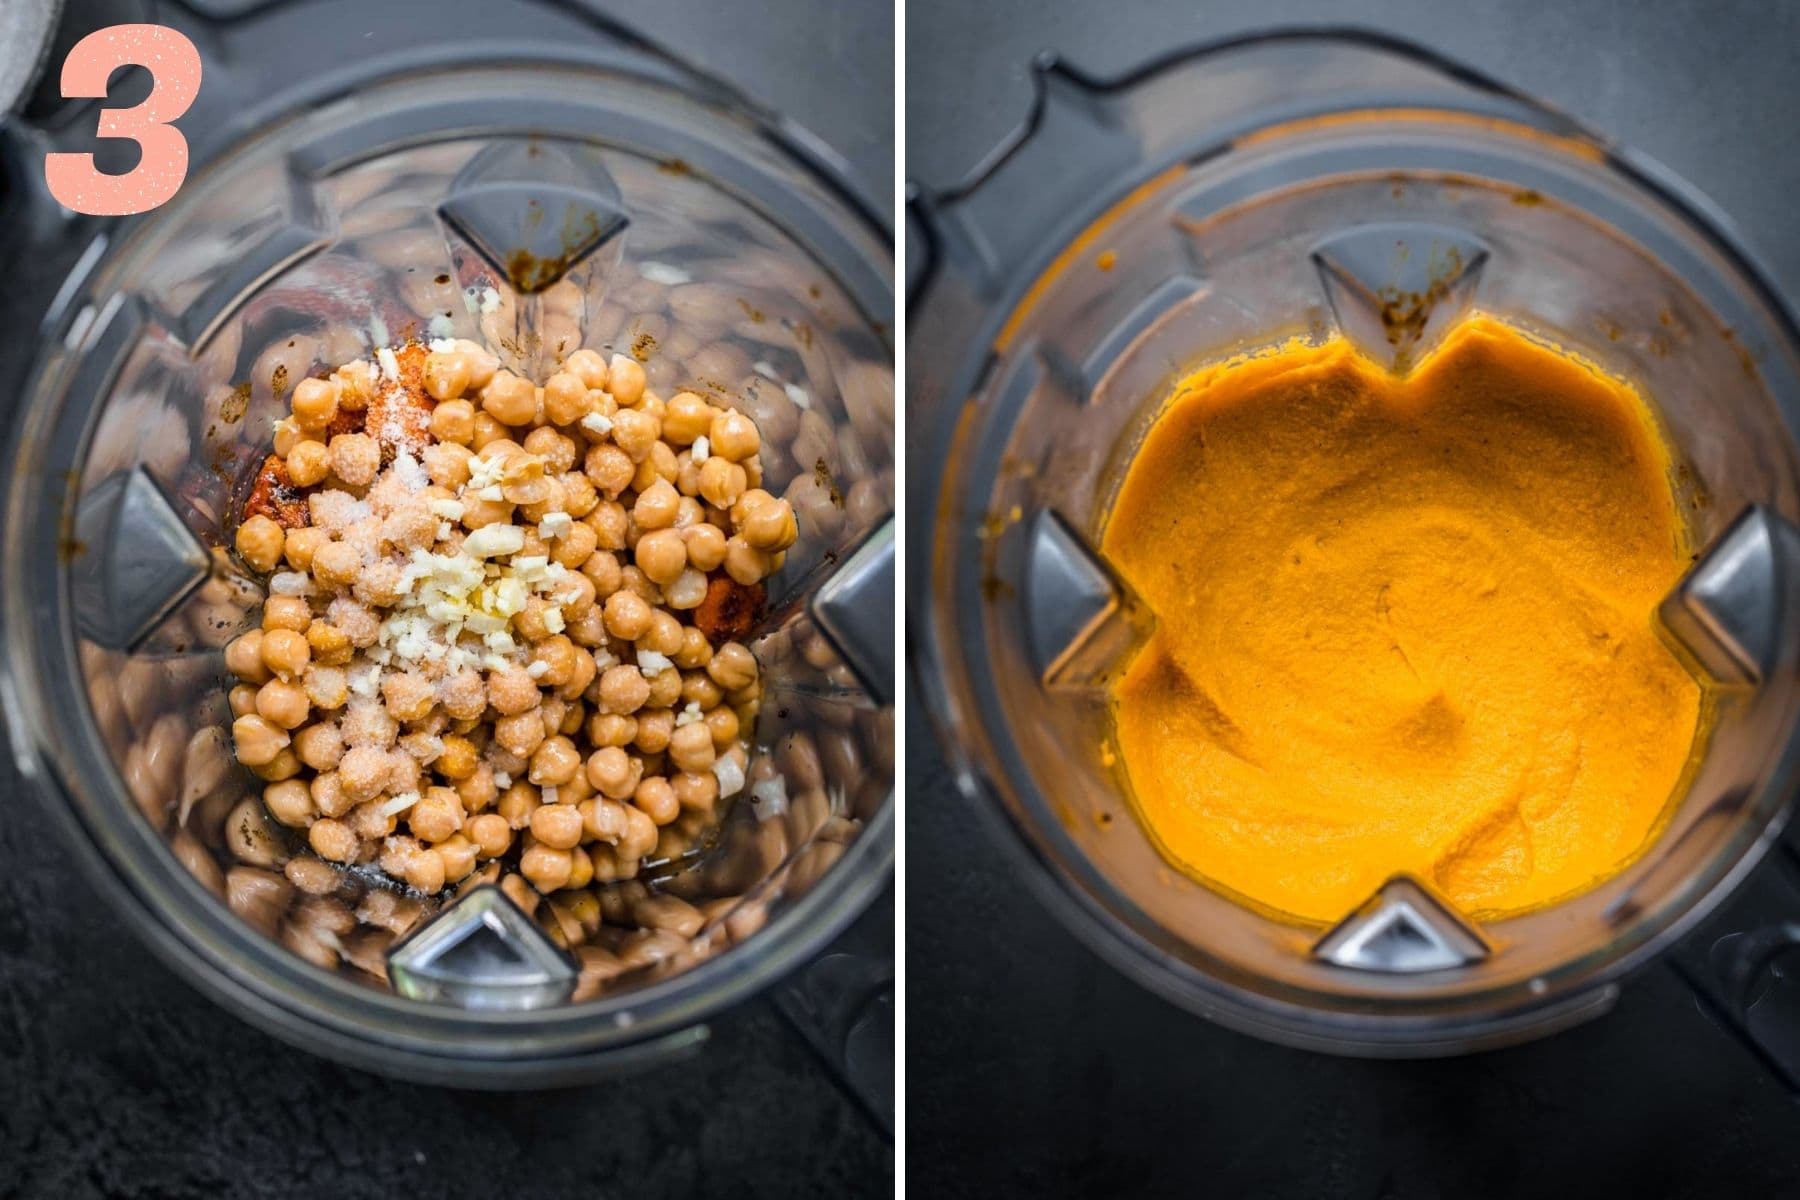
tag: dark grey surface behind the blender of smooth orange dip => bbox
[905,0,1800,1200]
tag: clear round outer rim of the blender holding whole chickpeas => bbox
[0,45,895,1065]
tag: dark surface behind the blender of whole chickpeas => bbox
[0,0,895,1200]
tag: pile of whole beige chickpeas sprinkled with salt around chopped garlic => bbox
[225,332,797,941]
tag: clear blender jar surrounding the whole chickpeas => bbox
[4,5,895,1110]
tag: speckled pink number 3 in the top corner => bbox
[43,25,200,216]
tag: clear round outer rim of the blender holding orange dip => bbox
[907,27,1800,1054]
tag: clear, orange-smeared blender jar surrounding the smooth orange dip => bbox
[909,32,1800,1054]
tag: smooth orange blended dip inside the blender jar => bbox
[1102,317,1701,921]
